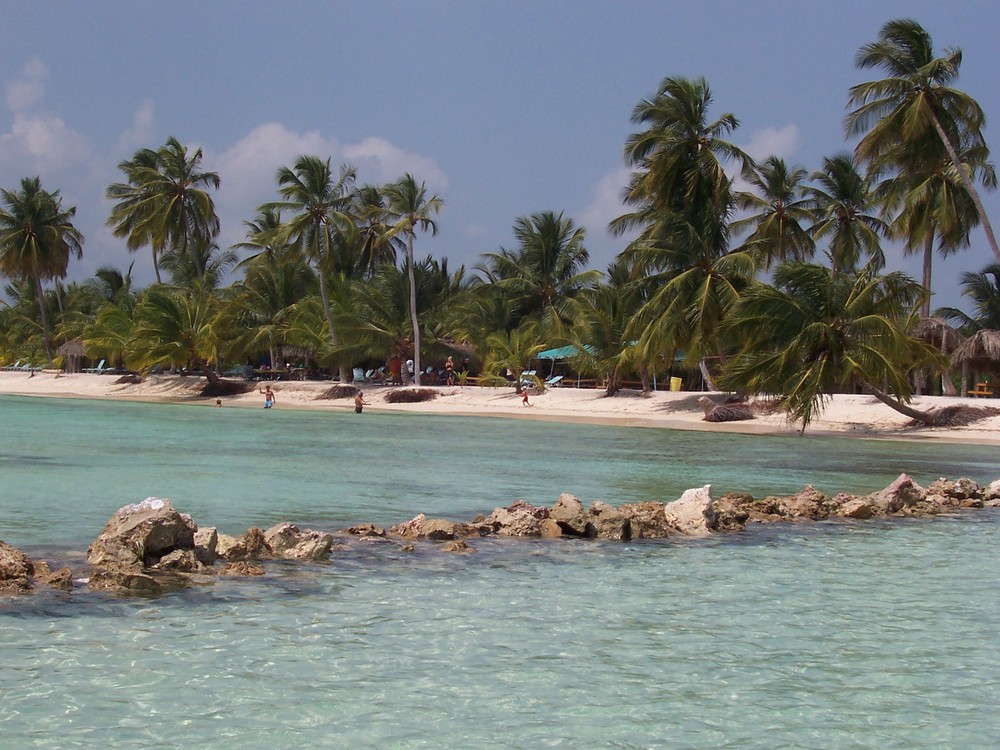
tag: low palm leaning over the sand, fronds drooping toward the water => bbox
[720,261,941,430]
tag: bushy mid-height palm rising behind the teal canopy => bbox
[482,211,600,339]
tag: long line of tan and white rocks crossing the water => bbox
[0,474,1000,596]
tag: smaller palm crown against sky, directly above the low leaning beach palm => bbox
[806,153,888,274]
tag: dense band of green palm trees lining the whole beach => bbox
[0,19,1000,427]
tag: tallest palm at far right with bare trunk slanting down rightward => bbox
[846,19,1000,262]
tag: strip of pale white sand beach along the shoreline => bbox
[0,372,1000,445]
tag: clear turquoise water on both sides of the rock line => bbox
[0,398,1000,748]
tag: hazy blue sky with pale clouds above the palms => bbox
[0,0,1000,312]
